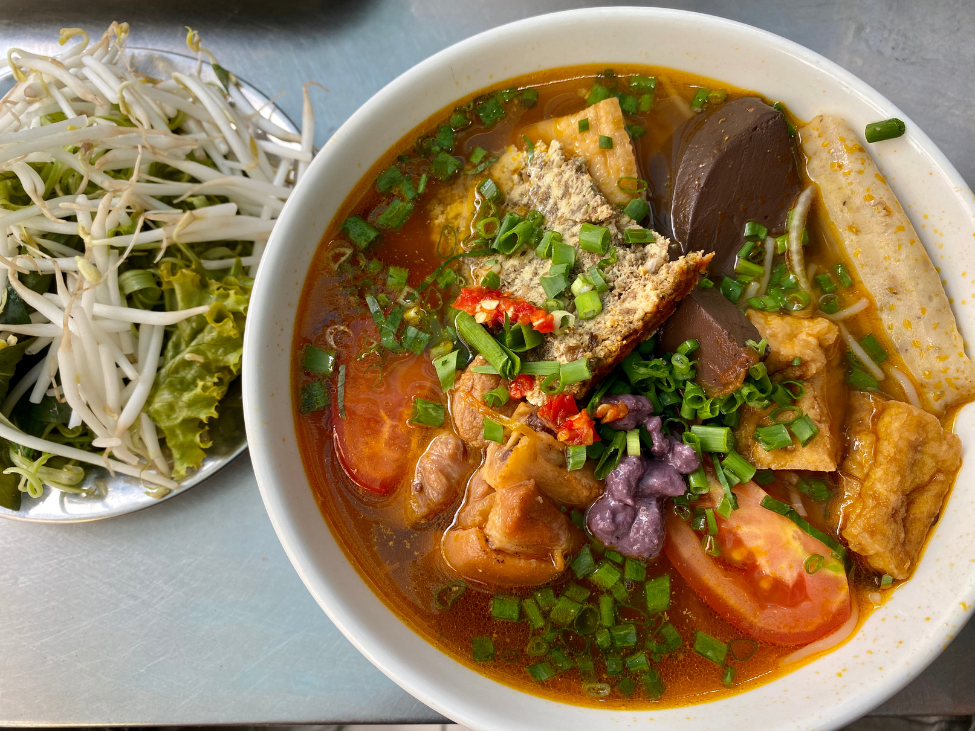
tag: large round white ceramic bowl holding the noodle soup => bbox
[244,8,975,731]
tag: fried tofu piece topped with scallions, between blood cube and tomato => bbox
[735,310,846,472]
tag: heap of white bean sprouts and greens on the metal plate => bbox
[0,23,314,509]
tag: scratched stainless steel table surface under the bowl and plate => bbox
[0,0,975,725]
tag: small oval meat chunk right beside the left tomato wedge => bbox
[406,431,477,525]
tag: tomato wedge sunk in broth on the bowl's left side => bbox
[332,323,443,495]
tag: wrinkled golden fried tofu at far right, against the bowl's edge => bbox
[830,393,961,579]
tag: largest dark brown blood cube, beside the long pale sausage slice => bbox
[671,97,801,274]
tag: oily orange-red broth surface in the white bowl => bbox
[292,66,888,708]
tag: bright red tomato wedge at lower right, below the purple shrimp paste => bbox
[664,483,851,645]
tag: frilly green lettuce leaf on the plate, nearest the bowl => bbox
[146,261,253,479]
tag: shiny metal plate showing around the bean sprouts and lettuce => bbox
[0,48,297,523]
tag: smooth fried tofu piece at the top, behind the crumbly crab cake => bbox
[523,97,638,206]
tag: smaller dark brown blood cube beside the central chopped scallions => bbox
[657,289,762,396]
